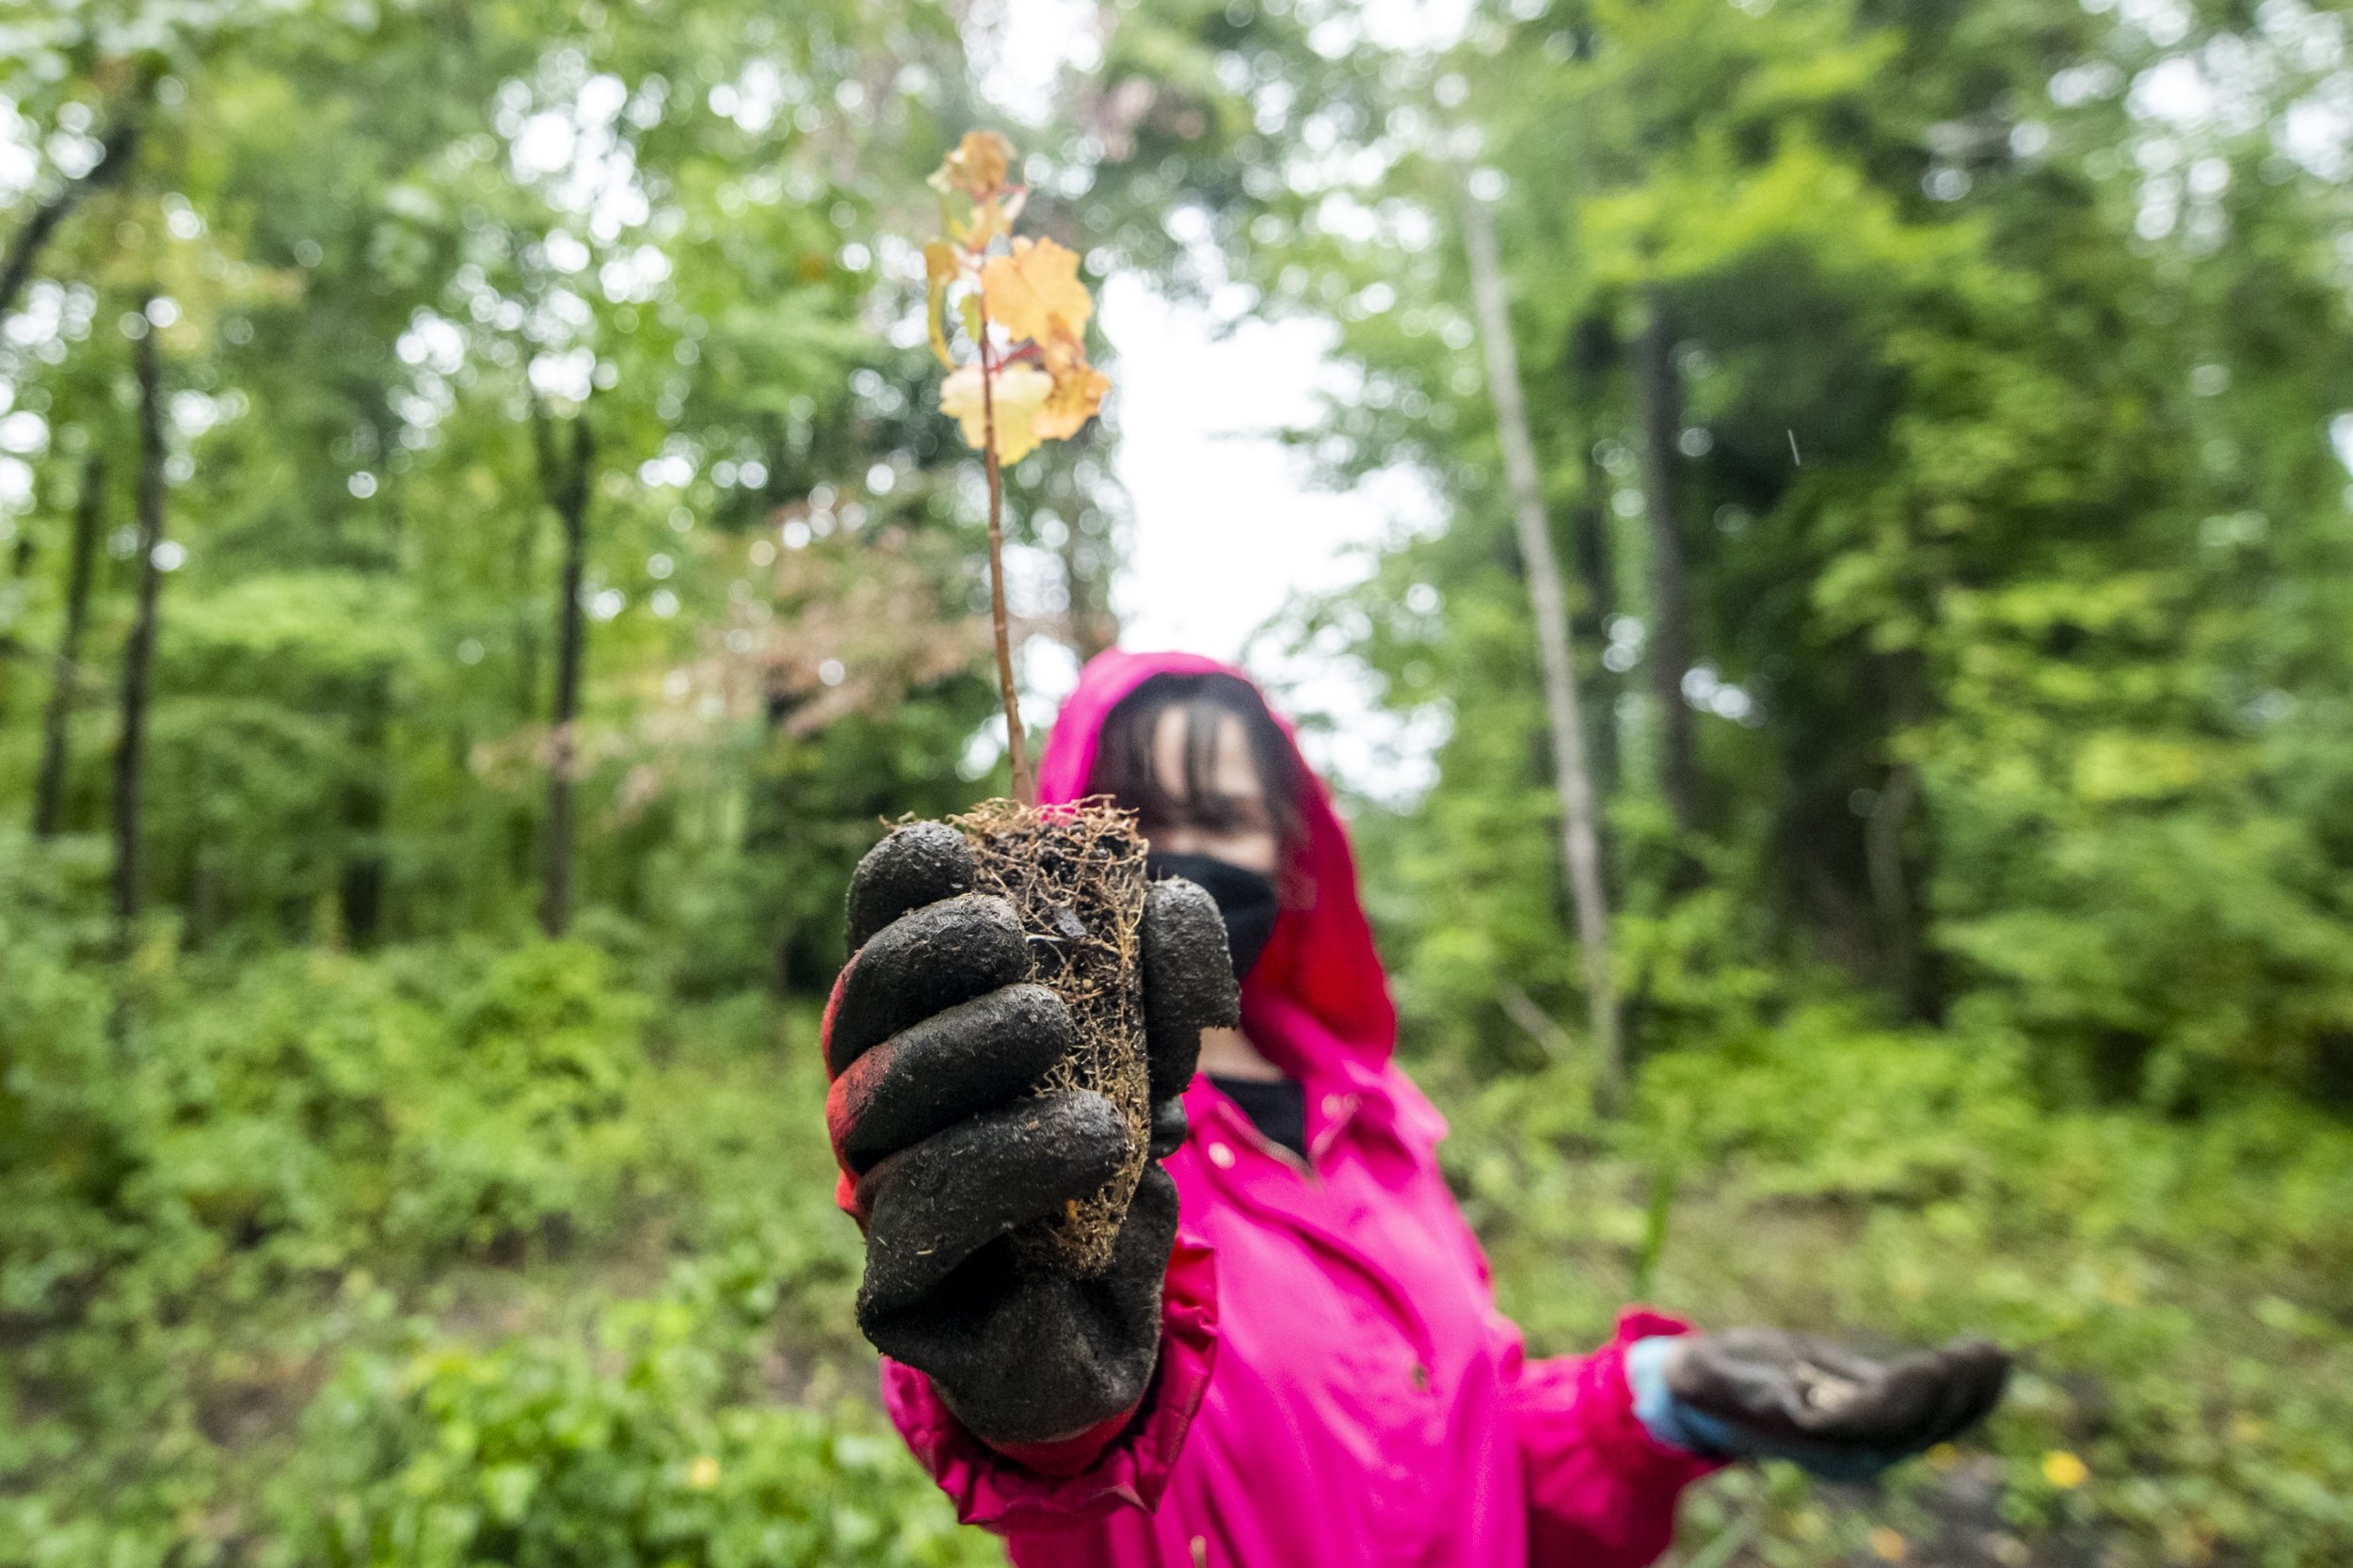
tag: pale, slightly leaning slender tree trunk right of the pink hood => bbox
[1464,198,1626,1107]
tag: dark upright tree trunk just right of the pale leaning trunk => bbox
[1636,292,1699,839]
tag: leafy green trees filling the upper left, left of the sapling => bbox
[0,3,988,951]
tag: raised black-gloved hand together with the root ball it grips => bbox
[826,819,1238,1446]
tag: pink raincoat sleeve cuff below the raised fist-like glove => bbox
[883,1236,1224,1532]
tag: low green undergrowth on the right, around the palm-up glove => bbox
[1440,1008,2353,1565]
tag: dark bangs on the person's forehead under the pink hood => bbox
[1087,673,1302,853]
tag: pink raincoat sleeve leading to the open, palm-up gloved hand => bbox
[1513,1309,1718,1568]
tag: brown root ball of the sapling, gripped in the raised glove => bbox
[951,798,1151,1273]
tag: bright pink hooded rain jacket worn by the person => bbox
[883,652,1711,1568]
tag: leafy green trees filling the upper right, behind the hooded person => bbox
[1104,0,2353,1109]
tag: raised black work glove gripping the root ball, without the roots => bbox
[824,822,1241,1446]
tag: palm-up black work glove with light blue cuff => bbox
[1628,1328,2009,1480]
